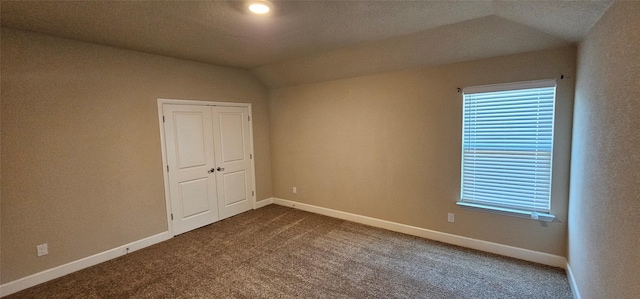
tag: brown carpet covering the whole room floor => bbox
[7,205,572,298]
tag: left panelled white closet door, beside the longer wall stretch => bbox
[163,104,219,235]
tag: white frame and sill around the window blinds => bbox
[456,79,557,222]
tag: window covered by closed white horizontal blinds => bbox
[458,80,556,221]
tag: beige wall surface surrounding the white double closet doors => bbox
[0,29,272,283]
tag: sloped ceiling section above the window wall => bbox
[252,16,571,87]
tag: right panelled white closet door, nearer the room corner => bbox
[213,106,253,219]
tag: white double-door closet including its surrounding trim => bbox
[158,99,255,235]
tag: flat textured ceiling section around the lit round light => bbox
[1,1,492,69]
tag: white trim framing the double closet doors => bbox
[158,98,257,236]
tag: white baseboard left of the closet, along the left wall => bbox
[0,232,171,297]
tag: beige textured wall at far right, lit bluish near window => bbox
[568,1,640,298]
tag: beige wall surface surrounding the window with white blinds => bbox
[270,47,575,256]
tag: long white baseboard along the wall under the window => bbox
[273,198,567,268]
